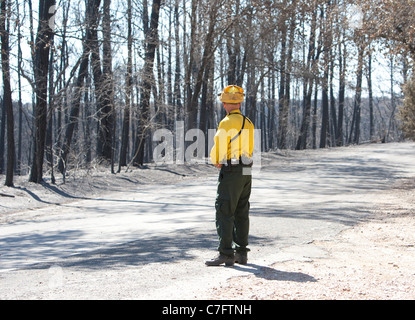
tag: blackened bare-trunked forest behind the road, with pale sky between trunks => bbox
[0,0,415,186]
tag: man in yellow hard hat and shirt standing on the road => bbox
[206,86,254,266]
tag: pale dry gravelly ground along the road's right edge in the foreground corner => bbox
[211,179,415,300]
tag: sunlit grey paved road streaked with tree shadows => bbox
[0,143,415,299]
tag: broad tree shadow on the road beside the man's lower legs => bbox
[17,229,270,270]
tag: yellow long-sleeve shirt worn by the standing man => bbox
[210,110,255,165]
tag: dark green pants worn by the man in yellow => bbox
[215,165,252,256]
